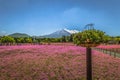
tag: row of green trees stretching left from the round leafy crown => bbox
[0,35,73,45]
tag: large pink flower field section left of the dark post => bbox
[0,45,86,80]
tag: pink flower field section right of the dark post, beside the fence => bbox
[92,50,120,80]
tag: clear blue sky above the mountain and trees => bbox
[0,0,120,36]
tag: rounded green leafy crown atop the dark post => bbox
[73,29,105,45]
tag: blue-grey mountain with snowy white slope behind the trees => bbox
[40,29,79,38]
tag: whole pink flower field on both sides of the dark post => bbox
[0,45,120,80]
